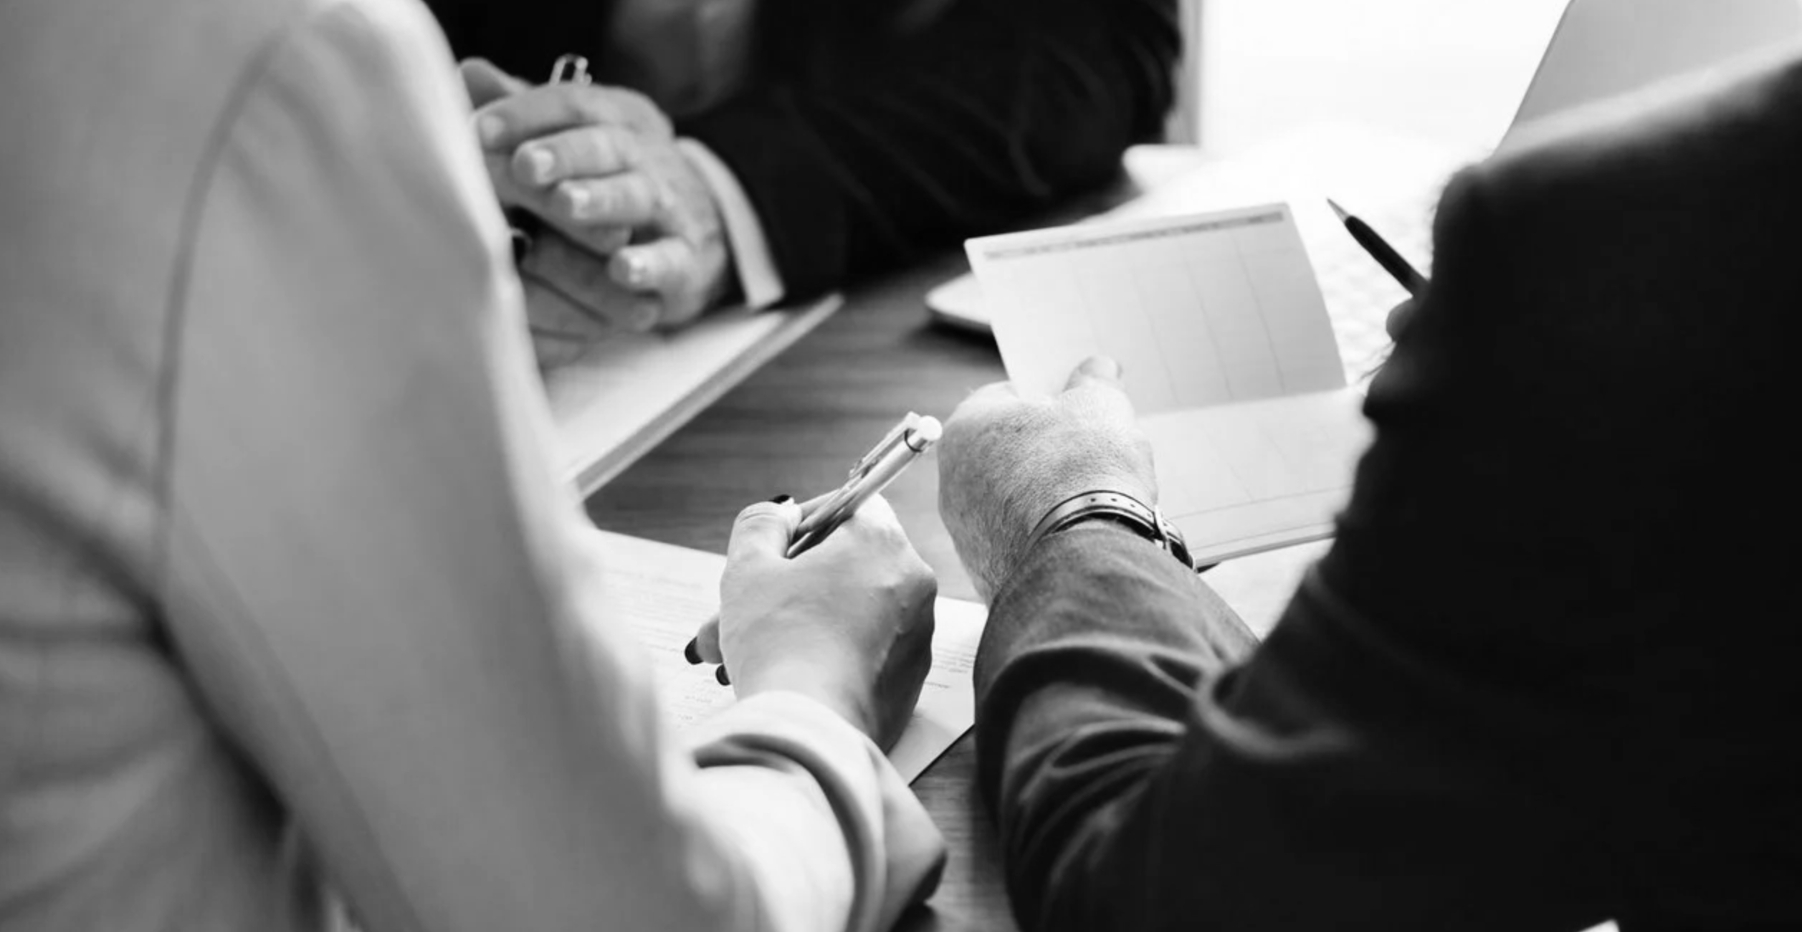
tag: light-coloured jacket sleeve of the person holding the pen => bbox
[164,0,939,932]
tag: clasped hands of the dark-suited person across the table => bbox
[463,59,733,335]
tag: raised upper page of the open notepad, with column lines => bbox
[966,204,1346,415]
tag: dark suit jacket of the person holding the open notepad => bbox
[977,49,1802,932]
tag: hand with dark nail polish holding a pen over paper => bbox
[690,496,939,750]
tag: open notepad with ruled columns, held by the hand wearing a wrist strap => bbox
[966,204,1370,562]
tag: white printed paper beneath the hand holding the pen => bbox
[596,532,986,782]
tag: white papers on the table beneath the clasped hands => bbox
[544,294,843,496]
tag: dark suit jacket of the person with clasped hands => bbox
[427,0,1180,297]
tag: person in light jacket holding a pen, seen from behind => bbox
[0,0,942,932]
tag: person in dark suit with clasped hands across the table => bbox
[431,0,1182,346]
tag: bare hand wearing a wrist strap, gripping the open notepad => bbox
[939,357,1157,602]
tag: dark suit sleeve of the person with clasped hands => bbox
[681,0,1180,296]
